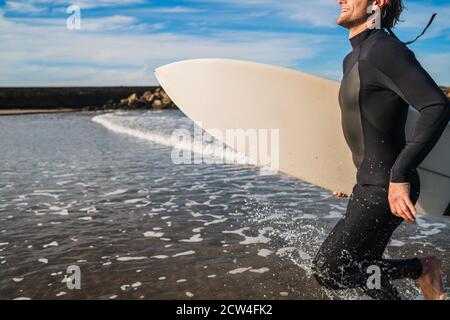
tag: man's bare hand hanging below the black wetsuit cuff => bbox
[388,182,417,222]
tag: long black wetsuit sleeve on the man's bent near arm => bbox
[370,42,450,182]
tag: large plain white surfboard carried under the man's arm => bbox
[155,59,450,217]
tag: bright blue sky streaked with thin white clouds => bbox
[0,0,450,86]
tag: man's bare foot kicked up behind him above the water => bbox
[417,257,445,300]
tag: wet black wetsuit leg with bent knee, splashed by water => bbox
[313,174,422,299]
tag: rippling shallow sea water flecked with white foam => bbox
[0,110,450,299]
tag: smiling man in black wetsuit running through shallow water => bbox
[313,0,450,299]
